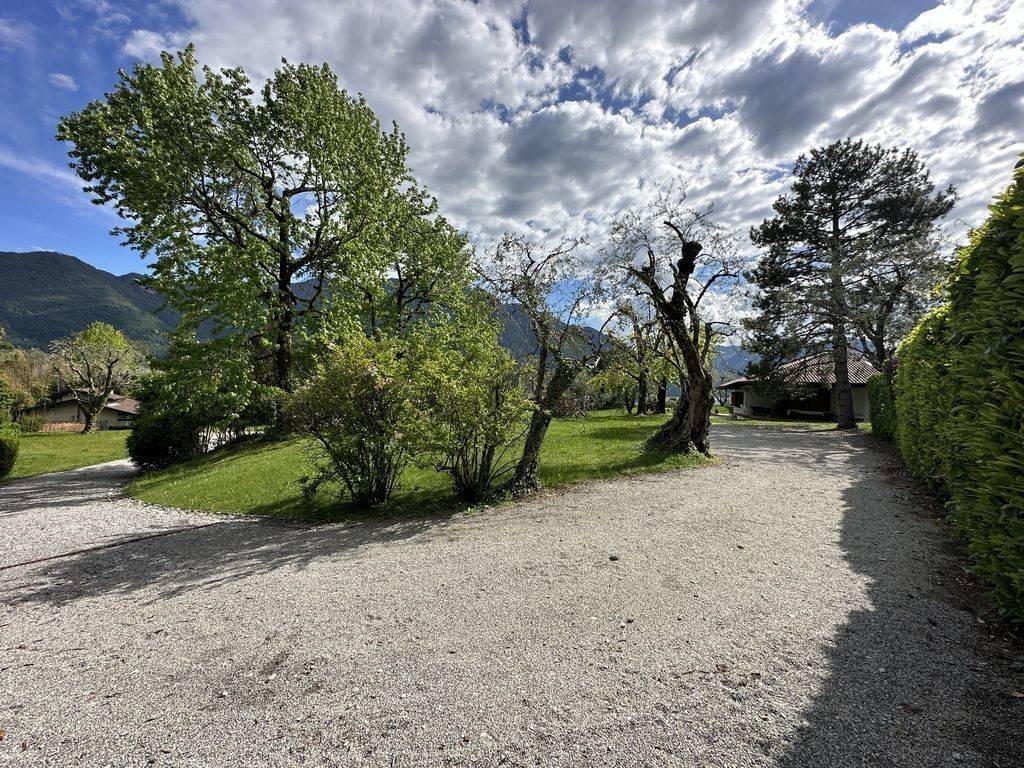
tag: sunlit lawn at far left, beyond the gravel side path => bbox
[0,430,128,482]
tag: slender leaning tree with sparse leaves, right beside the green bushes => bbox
[480,233,596,494]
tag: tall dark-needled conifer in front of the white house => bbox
[748,139,956,428]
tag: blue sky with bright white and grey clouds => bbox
[0,0,1024,273]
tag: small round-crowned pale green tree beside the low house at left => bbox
[50,323,142,432]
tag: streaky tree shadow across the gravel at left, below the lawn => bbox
[0,507,460,606]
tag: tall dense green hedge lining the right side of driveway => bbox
[896,156,1024,626]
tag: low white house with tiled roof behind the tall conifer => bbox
[718,349,878,421]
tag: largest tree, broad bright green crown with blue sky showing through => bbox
[57,46,436,390]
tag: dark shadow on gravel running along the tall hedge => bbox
[715,427,1024,768]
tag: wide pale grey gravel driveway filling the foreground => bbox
[0,426,1024,768]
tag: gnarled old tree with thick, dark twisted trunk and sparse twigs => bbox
[604,185,739,454]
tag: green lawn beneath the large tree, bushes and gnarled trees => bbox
[128,411,714,519]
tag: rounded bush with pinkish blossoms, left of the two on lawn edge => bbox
[289,336,424,506]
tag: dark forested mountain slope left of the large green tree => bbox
[0,251,177,349]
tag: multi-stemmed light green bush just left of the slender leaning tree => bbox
[412,323,530,502]
